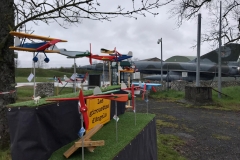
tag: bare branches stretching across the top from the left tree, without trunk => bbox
[13,0,173,30]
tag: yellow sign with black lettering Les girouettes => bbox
[87,98,111,130]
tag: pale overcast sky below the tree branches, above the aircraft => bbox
[18,1,218,68]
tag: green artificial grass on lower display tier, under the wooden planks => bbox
[50,112,155,160]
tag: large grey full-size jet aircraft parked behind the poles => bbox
[134,44,240,81]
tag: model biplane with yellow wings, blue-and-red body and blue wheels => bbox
[9,31,67,63]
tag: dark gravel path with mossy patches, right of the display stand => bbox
[136,99,240,160]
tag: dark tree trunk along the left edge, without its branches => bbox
[0,0,16,149]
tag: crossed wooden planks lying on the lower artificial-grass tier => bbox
[63,124,105,158]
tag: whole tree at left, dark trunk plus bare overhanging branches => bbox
[0,0,169,147]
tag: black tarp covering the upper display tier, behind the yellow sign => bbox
[7,91,126,160]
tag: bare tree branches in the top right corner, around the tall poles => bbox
[170,0,240,45]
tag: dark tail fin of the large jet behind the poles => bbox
[198,43,240,63]
